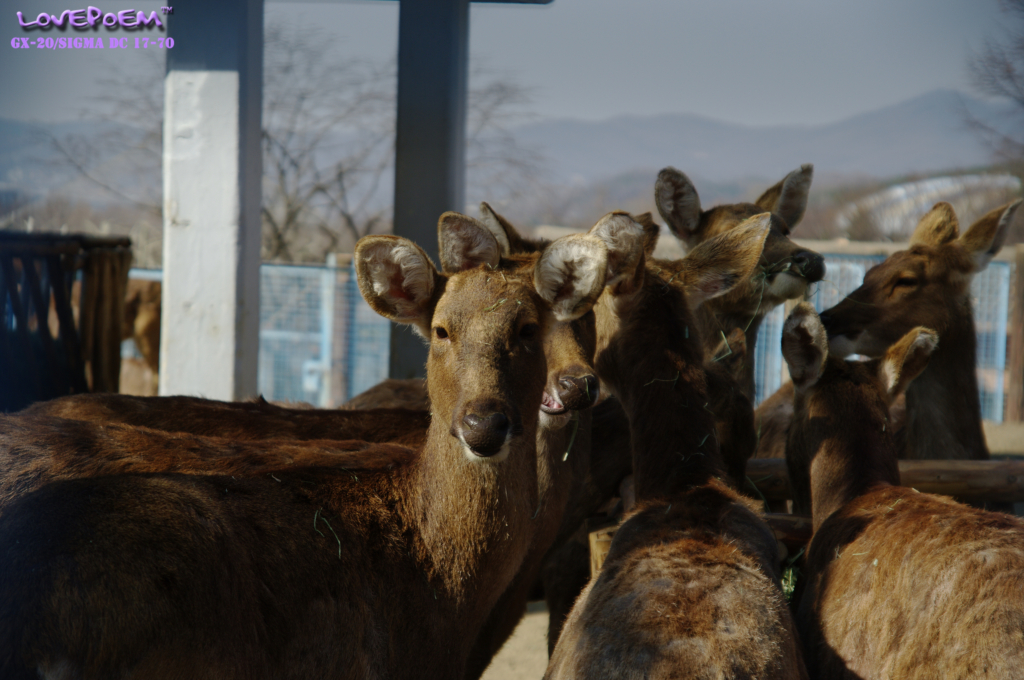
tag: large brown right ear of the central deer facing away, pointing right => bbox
[678,213,771,309]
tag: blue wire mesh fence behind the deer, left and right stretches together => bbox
[132,254,1013,423]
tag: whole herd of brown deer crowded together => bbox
[0,165,1024,680]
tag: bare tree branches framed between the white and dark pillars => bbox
[262,26,395,261]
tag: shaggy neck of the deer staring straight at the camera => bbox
[404,417,538,619]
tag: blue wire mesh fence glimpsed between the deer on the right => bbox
[755,253,1013,423]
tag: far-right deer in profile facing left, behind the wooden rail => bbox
[821,196,1020,460]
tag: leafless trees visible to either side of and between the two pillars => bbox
[19,22,541,265]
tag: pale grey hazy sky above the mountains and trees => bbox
[0,0,1006,125]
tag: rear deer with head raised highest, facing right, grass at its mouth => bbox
[652,164,825,399]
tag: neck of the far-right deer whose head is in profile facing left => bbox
[904,302,988,460]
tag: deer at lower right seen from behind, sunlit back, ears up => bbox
[782,304,1024,680]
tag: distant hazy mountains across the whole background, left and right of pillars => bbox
[0,90,1001,210]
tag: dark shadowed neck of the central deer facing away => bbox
[598,284,724,501]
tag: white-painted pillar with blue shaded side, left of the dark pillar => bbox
[160,0,263,400]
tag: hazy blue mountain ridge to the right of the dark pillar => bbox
[515,90,1001,183]
